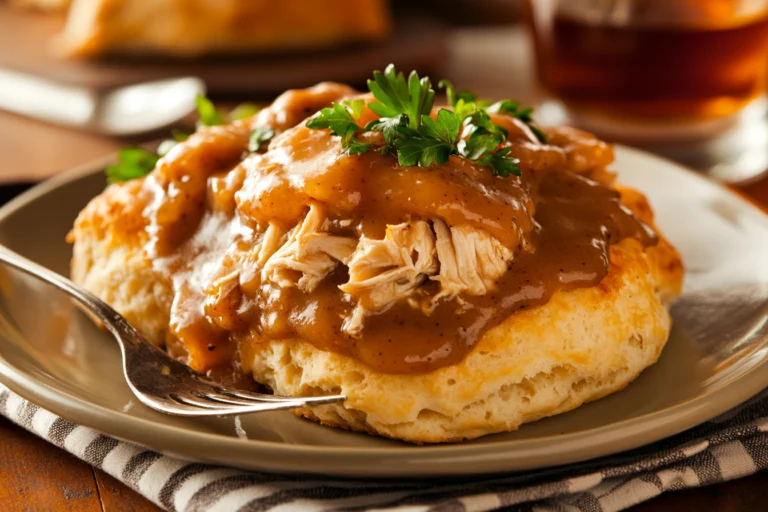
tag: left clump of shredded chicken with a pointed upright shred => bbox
[261,204,357,292]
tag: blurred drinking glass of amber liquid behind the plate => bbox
[526,0,768,181]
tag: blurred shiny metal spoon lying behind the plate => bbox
[0,68,205,136]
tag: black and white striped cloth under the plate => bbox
[0,385,768,512]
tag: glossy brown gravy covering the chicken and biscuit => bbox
[115,84,657,375]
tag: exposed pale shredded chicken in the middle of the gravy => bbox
[207,204,513,337]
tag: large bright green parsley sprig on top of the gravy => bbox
[307,64,546,177]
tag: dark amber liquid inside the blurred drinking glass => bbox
[534,13,768,122]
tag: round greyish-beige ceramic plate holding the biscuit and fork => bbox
[0,148,768,478]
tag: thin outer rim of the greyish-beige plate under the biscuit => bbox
[0,145,768,479]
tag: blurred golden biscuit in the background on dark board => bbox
[57,0,390,57]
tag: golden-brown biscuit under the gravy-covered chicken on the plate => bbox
[72,204,682,443]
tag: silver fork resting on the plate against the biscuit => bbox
[0,246,346,416]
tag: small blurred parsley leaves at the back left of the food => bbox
[106,94,274,183]
